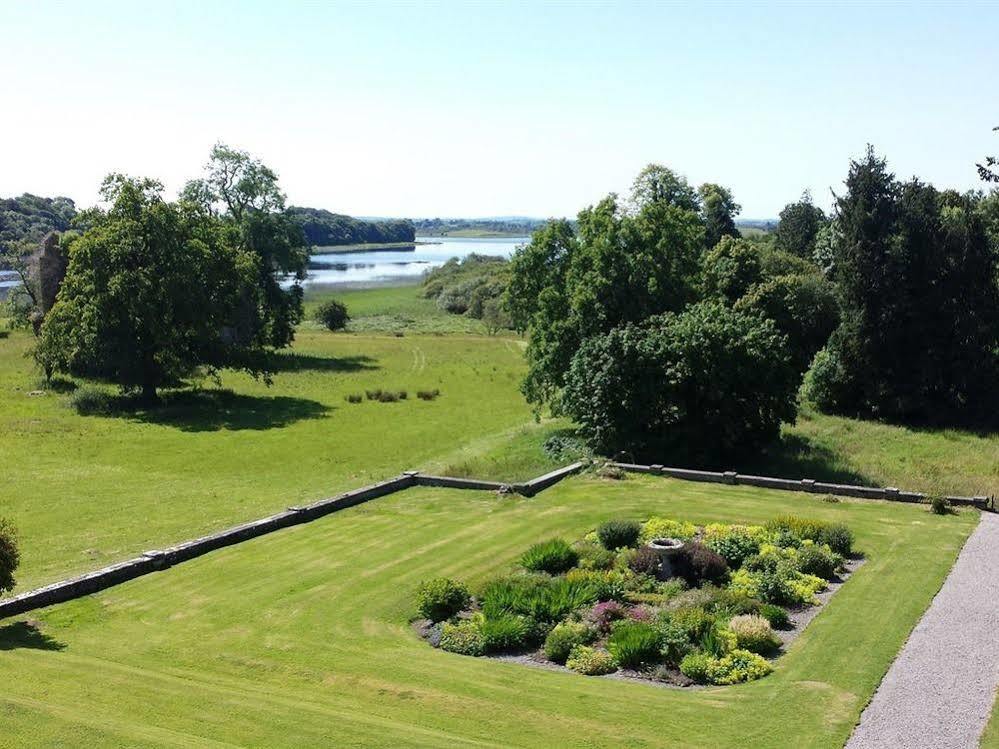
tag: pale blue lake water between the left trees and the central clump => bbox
[305,237,530,287]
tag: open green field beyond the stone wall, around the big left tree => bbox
[0,330,543,590]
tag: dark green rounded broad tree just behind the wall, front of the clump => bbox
[563,302,798,463]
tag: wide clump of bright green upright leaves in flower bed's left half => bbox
[481,576,596,625]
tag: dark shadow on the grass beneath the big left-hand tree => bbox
[124,390,330,432]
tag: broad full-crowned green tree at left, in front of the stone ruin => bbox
[36,175,266,401]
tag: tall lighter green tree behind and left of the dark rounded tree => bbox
[508,187,704,411]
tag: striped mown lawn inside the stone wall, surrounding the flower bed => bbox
[0,473,977,747]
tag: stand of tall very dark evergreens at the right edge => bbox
[808,150,999,426]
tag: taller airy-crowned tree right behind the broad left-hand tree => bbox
[182,143,308,347]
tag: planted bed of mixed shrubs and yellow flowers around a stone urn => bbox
[416,516,853,686]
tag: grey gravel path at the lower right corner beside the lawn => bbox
[846,513,999,749]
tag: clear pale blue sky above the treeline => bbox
[0,0,999,218]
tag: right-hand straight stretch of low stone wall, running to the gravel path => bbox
[613,463,995,510]
